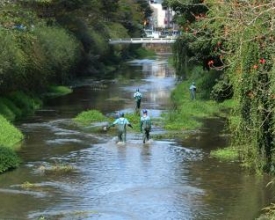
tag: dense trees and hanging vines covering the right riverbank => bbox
[163,0,275,173]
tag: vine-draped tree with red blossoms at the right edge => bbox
[209,1,275,173]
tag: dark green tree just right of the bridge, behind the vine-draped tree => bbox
[163,0,229,101]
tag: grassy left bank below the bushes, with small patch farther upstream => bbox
[0,86,72,173]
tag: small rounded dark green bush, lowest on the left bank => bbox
[0,147,21,173]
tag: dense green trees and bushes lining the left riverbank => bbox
[0,0,152,173]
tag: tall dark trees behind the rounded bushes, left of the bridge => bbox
[18,0,152,75]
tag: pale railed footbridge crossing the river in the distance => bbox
[109,38,176,44]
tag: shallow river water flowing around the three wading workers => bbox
[0,57,275,220]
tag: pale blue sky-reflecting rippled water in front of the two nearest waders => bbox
[28,139,204,219]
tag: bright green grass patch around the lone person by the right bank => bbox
[163,80,237,131]
